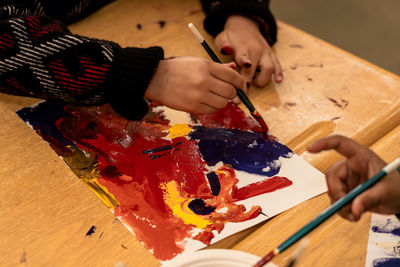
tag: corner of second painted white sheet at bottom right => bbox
[365,213,400,267]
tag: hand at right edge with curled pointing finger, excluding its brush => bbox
[307,135,400,221]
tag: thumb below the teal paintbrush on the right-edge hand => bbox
[351,192,381,220]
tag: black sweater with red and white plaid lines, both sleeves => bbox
[0,0,276,120]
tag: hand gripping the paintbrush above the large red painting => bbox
[145,57,245,114]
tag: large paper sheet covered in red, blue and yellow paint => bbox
[17,102,326,261]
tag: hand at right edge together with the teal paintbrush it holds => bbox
[254,136,400,267]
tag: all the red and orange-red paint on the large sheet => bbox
[48,103,291,260]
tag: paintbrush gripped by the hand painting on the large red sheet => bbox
[188,23,268,133]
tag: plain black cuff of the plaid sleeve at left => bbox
[105,46,164,120]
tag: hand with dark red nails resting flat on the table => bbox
[215,15,282,87]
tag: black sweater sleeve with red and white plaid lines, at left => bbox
[0,1,164,120]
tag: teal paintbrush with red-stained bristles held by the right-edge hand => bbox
[253,158,400,267]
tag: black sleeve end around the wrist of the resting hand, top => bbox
[201,0,277,45]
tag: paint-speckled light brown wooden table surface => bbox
[0,0,400,266]
